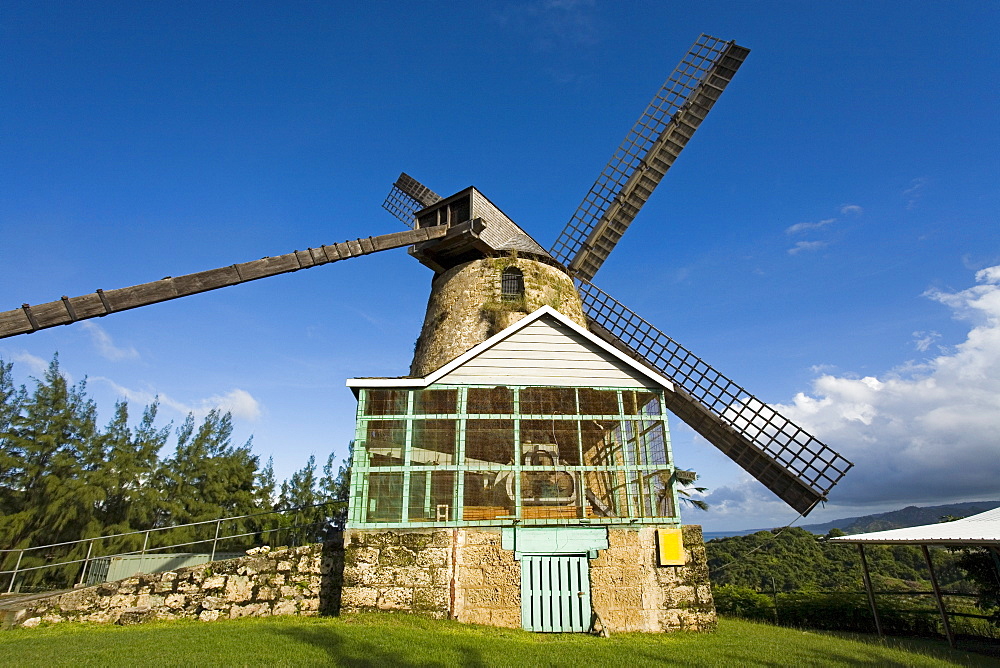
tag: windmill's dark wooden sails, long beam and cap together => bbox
[0,35,852,513]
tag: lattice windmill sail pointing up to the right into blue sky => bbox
[550,35,750,280]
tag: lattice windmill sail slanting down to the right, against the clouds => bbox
[577,280,853,514]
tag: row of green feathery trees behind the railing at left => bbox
[0,356,349,580]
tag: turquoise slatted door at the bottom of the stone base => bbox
[521,554,591,633]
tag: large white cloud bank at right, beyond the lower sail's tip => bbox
[776,266,1000,504]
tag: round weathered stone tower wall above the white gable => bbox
[410,257,586,376]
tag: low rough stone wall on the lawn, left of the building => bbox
[0,540,343,628]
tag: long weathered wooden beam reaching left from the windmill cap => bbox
[0,225,448,339]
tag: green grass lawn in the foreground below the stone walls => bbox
[0,614,1000,668]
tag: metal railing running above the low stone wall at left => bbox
[0,501,346,594]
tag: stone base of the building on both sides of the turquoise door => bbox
[342,526,715,633]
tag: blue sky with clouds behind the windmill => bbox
[0,0,1000,530]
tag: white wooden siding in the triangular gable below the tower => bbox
[436,317,659,388]
